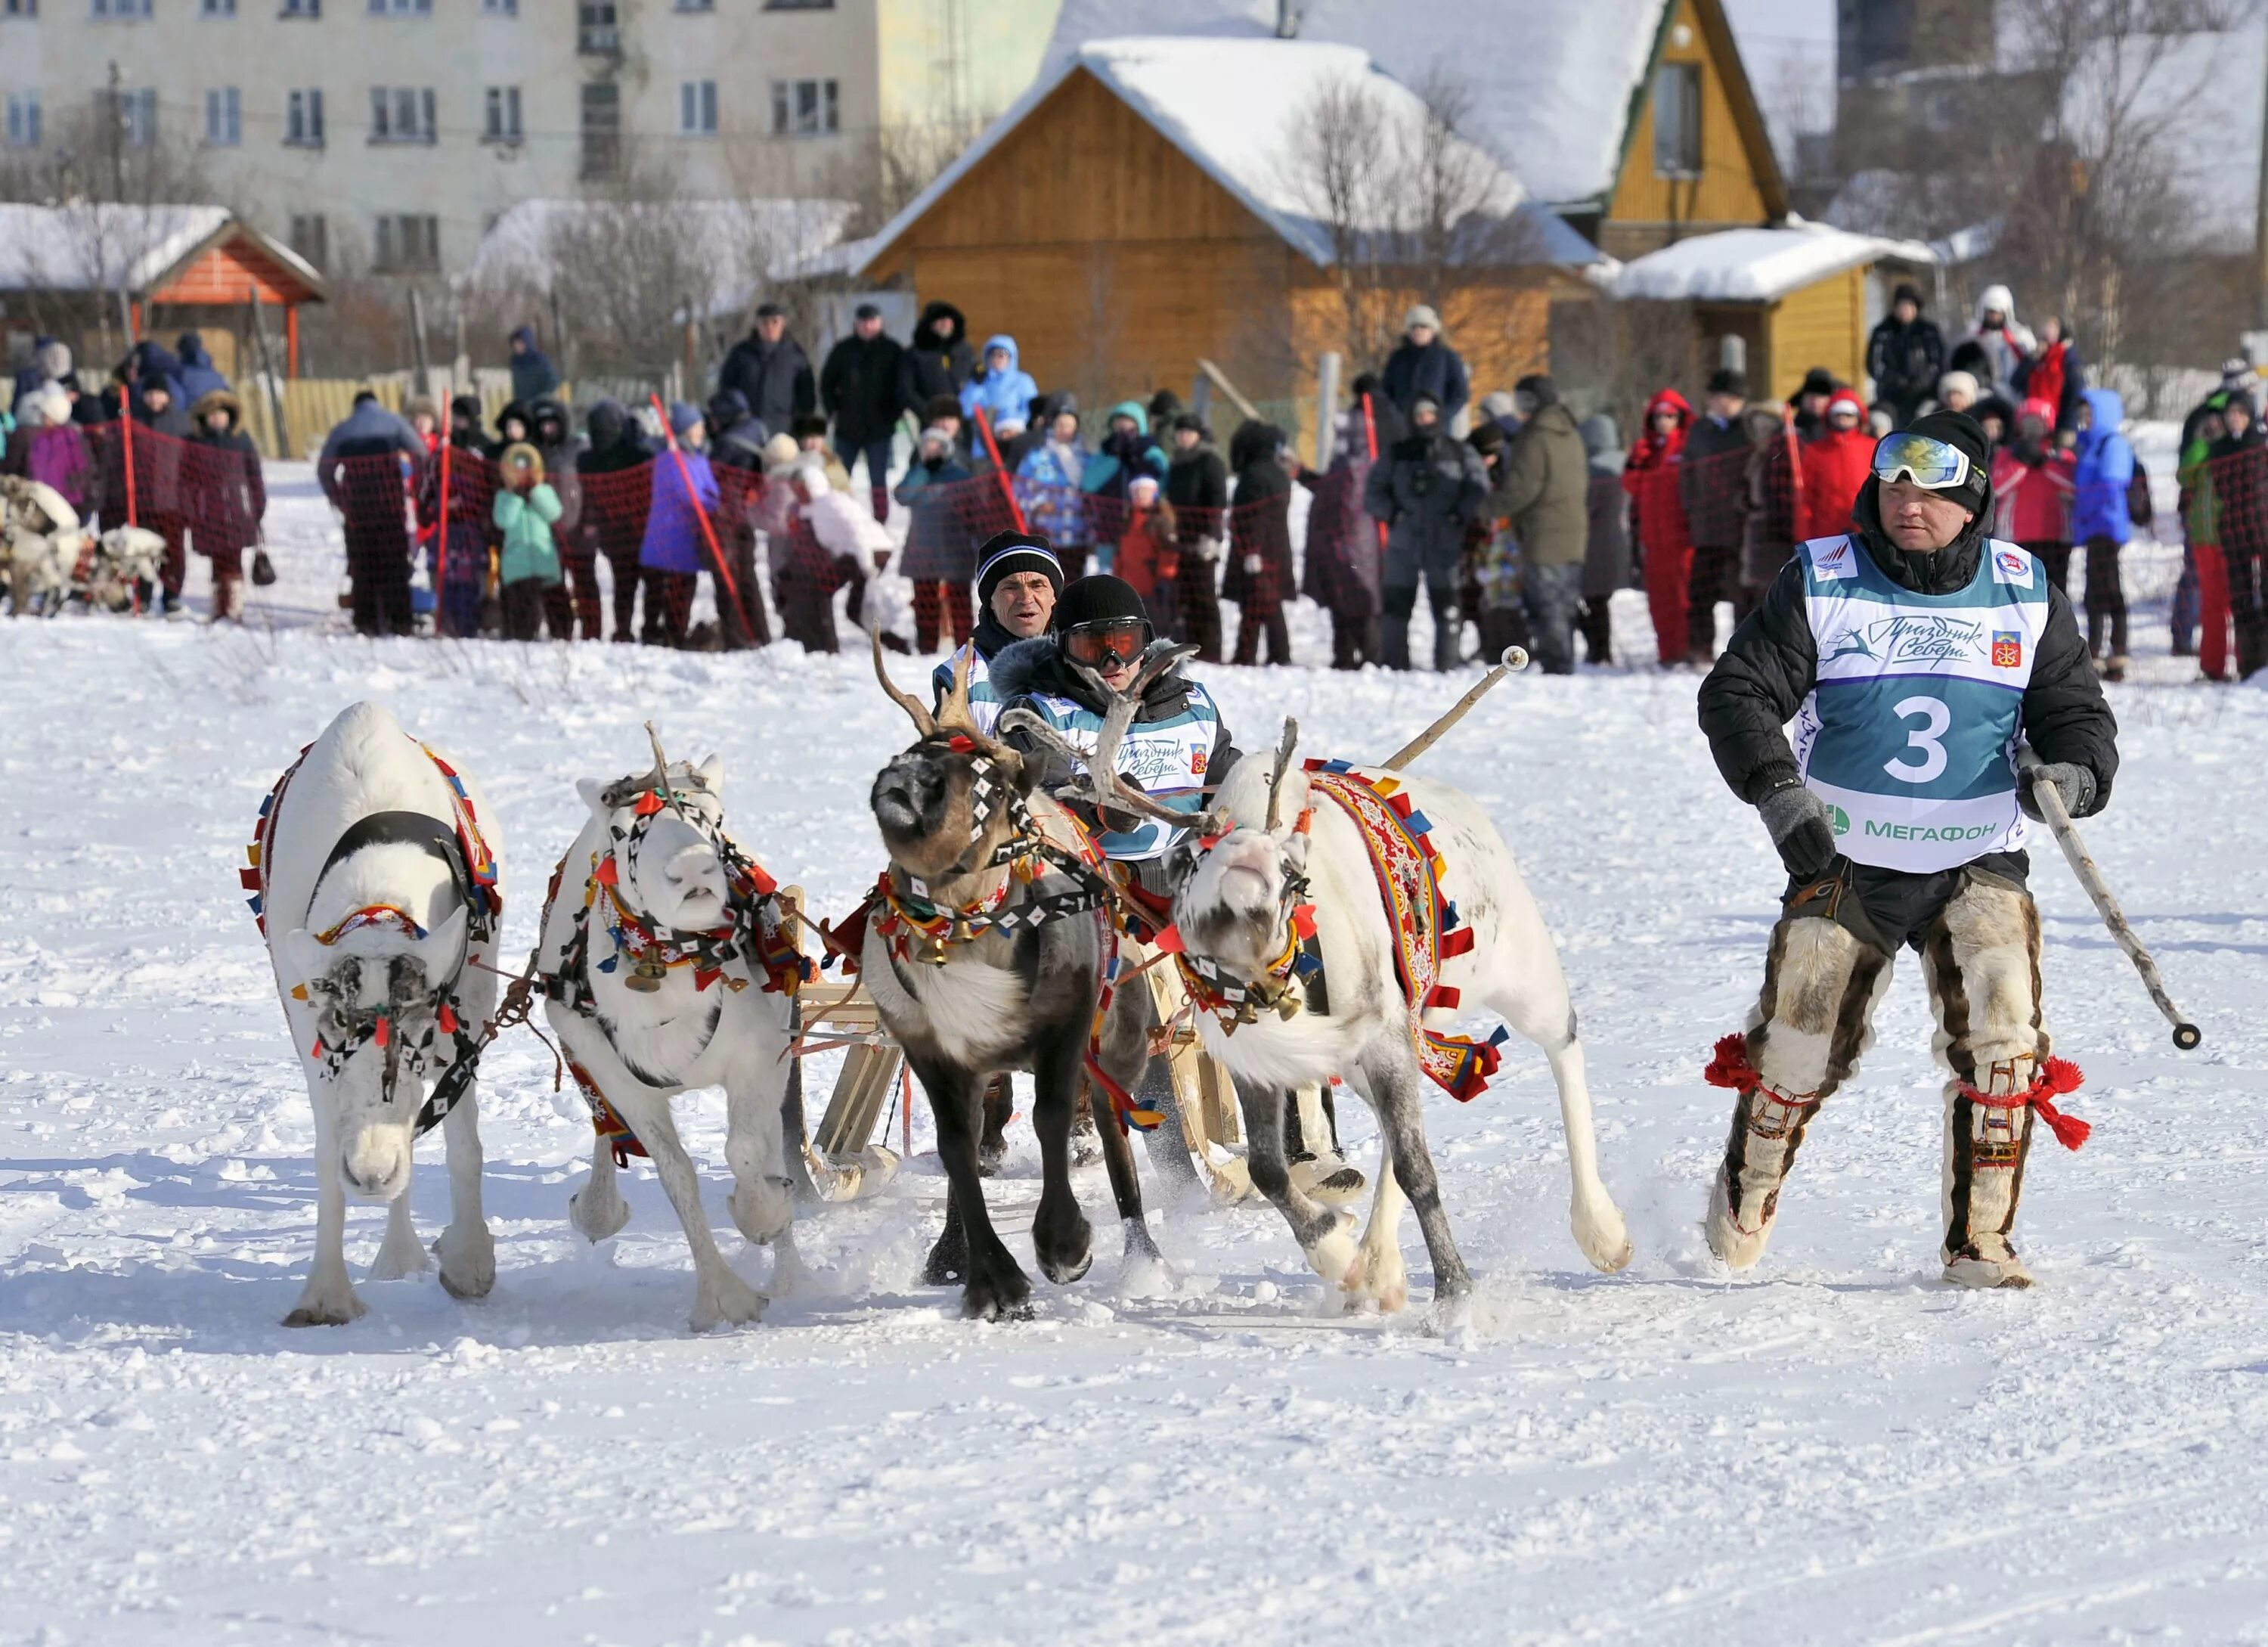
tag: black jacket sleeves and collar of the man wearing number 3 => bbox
[1701,479,2118,812]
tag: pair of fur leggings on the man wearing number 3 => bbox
[1708,869,2048,1286]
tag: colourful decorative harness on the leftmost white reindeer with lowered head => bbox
[238,740,503,1137]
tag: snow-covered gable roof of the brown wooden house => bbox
[853,36,1599,272]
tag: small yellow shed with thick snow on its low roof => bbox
[1610,220,1937,399]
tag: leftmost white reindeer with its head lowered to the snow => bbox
[259,703,501,1327]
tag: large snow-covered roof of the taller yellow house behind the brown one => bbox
[1048,0,1669,209]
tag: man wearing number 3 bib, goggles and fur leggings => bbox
[1701,413,2118,1286]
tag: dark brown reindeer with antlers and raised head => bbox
[846,640,1186,1320]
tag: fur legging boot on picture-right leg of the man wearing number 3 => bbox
[1923,876,2084,1286]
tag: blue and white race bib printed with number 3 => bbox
[1794,535,2048,873]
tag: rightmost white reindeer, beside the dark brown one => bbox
[1021,658,1631,1311]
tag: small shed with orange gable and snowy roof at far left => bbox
[0,202,324,377]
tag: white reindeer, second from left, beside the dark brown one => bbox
[538,746,803,1332]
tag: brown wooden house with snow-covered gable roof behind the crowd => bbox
[853,36,1599,451]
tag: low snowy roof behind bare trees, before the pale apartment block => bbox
[458,200,857,313]
